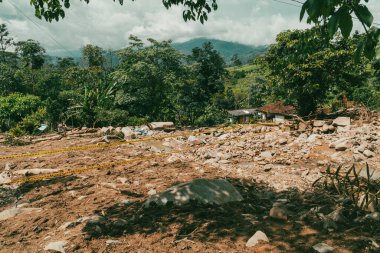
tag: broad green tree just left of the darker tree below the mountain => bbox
[111,36,184,120]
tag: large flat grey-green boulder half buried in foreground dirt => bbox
[144,179,243,207]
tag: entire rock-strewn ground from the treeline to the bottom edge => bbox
[0,113,380,252]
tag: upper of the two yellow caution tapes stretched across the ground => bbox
[0,123,275,160]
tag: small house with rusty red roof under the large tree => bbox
[257,101,296,122]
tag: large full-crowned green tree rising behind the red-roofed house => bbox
[264,27,367,115]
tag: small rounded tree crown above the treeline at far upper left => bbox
[16,39,46,69]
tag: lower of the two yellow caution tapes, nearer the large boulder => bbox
[3,131,276,185]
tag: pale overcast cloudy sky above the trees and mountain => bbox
[0,0,380,55]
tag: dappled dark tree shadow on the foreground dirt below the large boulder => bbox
[83,178,380,252]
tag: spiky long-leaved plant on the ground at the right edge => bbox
[313,164,380,210]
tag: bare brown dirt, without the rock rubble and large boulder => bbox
[0,125,380,252]
